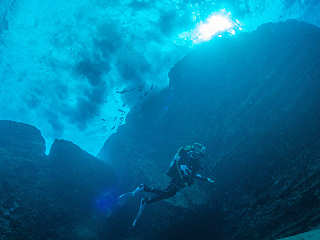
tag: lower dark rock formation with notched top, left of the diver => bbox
[0,121,115,240]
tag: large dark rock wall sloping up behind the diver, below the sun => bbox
[100,21,320,240]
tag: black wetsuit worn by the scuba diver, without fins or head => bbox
[144,148,201,204]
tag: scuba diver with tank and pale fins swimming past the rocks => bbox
[119,143,215,227]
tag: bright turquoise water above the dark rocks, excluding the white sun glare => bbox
[0,0,320,154]
